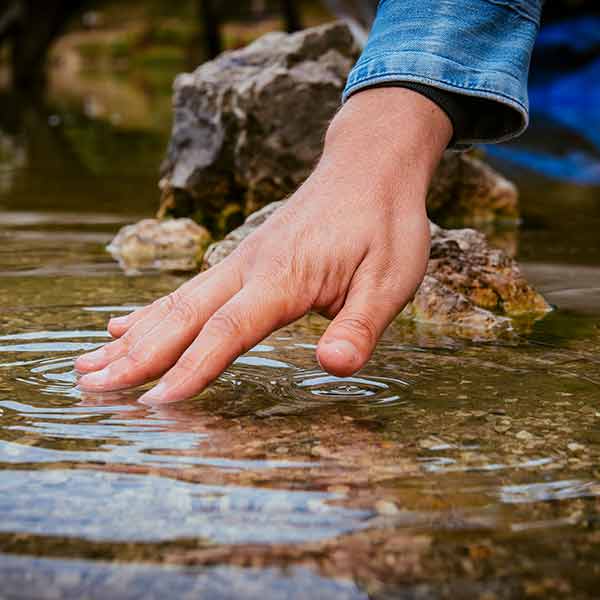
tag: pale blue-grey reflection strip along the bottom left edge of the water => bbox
[0,557,367,600]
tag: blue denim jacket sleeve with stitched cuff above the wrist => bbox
[343,0,543,145]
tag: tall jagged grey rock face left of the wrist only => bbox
[163,24,358,225]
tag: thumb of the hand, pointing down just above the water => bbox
[317,288,399,377]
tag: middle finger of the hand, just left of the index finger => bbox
[78,271,240,392]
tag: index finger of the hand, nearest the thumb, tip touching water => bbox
[140,284,302,405]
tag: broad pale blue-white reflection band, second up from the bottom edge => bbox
[0,472,368,544]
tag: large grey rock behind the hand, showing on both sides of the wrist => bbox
[159,23,518,227]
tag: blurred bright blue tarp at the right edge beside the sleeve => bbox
[487,17,600,185]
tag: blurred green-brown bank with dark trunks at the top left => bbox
[0,0,329,88]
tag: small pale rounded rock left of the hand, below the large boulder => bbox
[106,219,211,274]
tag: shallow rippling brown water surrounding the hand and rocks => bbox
[0,70,600,600]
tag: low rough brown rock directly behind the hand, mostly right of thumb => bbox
[203,202,551,339]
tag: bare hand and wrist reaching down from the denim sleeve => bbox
[75,88,452,405]
